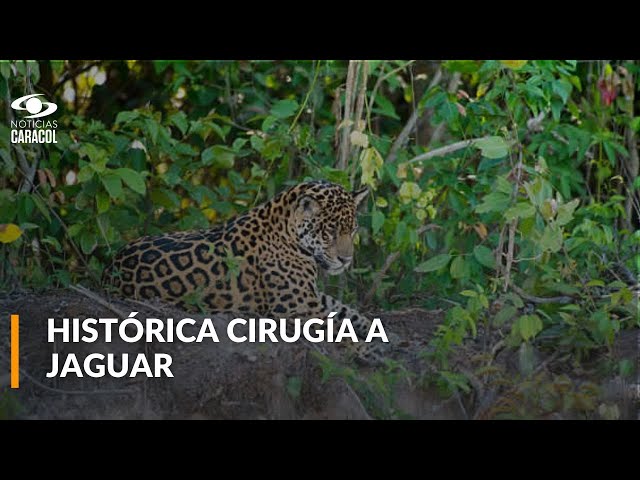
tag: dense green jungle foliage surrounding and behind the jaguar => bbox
[0,60,640,415]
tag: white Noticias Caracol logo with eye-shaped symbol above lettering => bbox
[11,93,58,143]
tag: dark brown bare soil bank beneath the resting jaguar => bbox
[0,290,638,419]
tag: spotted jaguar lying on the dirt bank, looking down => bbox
[103,180,385,364]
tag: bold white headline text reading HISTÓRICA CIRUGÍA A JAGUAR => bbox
[46,312,389,378]
